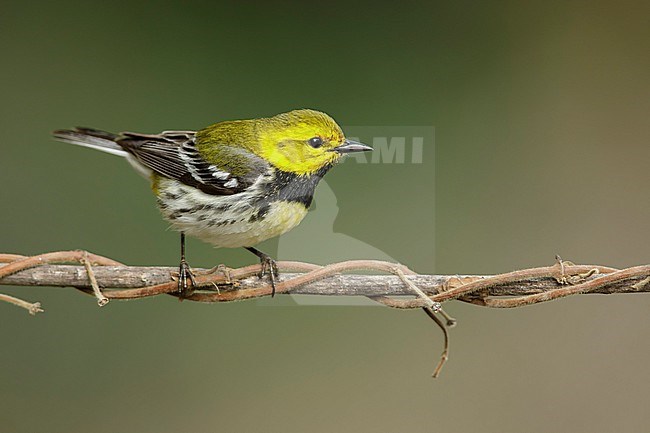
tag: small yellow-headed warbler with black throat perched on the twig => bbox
[54,110,372,295]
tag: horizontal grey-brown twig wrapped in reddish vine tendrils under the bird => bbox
[0,250,650,377]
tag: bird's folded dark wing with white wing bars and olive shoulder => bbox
[116,131,269,195]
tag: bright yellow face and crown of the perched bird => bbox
[258,110,345,175]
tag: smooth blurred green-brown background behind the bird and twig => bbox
[0,0,650,433]
